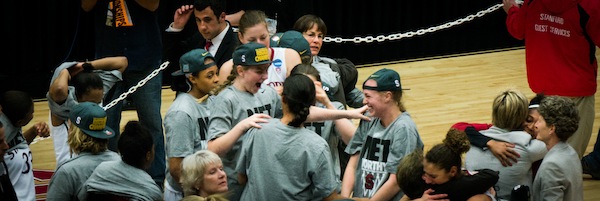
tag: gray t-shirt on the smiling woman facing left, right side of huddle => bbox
[345,112,423,200]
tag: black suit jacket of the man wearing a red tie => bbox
[163,22,240,84]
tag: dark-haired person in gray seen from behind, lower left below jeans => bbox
[78,121,163,201]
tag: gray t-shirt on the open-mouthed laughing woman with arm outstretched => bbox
[208,86,282,200]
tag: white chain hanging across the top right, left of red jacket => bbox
[323,4,502,43]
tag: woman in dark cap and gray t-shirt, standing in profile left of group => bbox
[164,49,219,201]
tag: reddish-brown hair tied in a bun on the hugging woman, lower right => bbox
[425,128,471,176]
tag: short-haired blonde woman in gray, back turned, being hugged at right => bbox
[465,89,547,200]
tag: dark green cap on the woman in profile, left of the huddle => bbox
[171,48,217,76]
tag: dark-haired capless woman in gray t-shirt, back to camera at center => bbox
[237,74,343,200]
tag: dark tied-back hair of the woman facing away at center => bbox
[281,74,316,127]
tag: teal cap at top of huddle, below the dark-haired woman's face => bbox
[271,30,311,57]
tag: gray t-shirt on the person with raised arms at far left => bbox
[46,61,123,121]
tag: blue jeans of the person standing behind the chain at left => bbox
[104,62,166,189]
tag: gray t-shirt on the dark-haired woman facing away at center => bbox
[237,119,337,200]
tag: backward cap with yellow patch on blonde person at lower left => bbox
[69,102,115,139]
